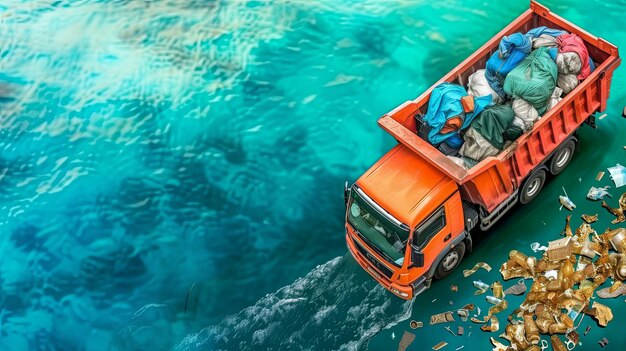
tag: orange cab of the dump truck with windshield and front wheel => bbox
[346,144,471,299]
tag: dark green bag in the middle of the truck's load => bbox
[470,105,515,150]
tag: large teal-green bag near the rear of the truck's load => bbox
[504,47,558,117]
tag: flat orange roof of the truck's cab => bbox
[357,144,458,227]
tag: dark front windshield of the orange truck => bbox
[348,190,409,266]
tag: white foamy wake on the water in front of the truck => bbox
[176,255,412,351]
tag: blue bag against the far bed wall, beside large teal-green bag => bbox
[485,33,532,99]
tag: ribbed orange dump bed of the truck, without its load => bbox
[378,1,621,212]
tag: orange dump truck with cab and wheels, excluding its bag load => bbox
[344,2,621,299]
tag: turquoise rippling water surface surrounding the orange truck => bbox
[0,0,626,351]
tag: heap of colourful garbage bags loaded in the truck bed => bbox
[422,26,595,168]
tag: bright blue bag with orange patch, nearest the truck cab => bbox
[424,83,491,145]
